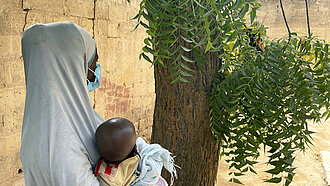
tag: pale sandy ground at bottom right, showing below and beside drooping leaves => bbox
[216,119,330,186]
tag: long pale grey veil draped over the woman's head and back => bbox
[20,22,104,186]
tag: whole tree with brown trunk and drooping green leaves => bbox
[127,0,330,185]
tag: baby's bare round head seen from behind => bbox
[95,118,136,162]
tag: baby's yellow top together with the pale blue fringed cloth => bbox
[95,138,177,186]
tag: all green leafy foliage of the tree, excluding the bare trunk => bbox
[130,0,330,185]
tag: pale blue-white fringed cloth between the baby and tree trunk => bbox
[131,138,177,186]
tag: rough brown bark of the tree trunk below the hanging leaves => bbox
[151,54,221,186]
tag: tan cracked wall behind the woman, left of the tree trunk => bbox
[0,0,155,185]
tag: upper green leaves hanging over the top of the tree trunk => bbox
[131,0,260,83]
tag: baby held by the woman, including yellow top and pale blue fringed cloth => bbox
[95,118,176,186]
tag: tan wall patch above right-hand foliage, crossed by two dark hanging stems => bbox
[258,0,330,42]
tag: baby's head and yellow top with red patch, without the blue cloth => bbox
[95,118,140,186]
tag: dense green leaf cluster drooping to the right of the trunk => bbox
[210,37,330,185]
